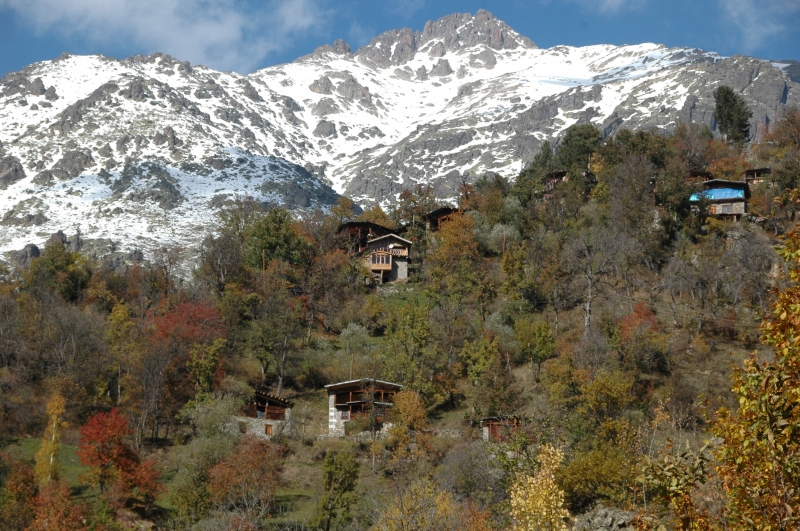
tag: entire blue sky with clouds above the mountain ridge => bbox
[0,0,800,76]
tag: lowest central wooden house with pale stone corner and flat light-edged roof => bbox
[325,378,403,437]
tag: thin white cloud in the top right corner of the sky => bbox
[719,0,800,52]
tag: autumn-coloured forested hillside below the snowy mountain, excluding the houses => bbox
[0,109,800,531]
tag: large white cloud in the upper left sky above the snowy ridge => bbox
[0,0,325,73]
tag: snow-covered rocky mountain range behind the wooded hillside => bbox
[0,11,800,266]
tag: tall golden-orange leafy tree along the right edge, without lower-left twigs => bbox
[713,231,800,531]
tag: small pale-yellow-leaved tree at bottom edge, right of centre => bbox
[511,445,569,531]
